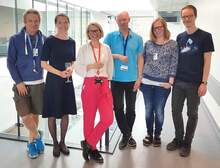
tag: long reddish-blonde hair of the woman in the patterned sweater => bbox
[150,17,170,42]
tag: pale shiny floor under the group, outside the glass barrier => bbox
[0,93,220,168]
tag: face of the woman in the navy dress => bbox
[56,16,69,33]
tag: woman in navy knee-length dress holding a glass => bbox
[41,14,76,157]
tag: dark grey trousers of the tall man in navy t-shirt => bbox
[172,80,200,145]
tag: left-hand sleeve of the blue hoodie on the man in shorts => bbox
[7,37,23,84]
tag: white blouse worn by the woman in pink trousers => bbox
[75,43,113,80]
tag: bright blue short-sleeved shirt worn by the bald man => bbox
[104,30,143,82]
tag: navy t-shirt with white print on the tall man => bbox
[176,29,214,84]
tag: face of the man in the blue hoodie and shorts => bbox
[24,13,40,35]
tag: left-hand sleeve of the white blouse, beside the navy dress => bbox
[75,47,87,78]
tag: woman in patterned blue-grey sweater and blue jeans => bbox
[141,17,178,147]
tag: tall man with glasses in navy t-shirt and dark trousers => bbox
[167,5,214,157]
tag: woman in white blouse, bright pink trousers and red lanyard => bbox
[76,23,113,163]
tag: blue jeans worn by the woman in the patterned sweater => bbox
[141,84,170,137]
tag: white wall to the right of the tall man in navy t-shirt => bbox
[190,0,220,128]
